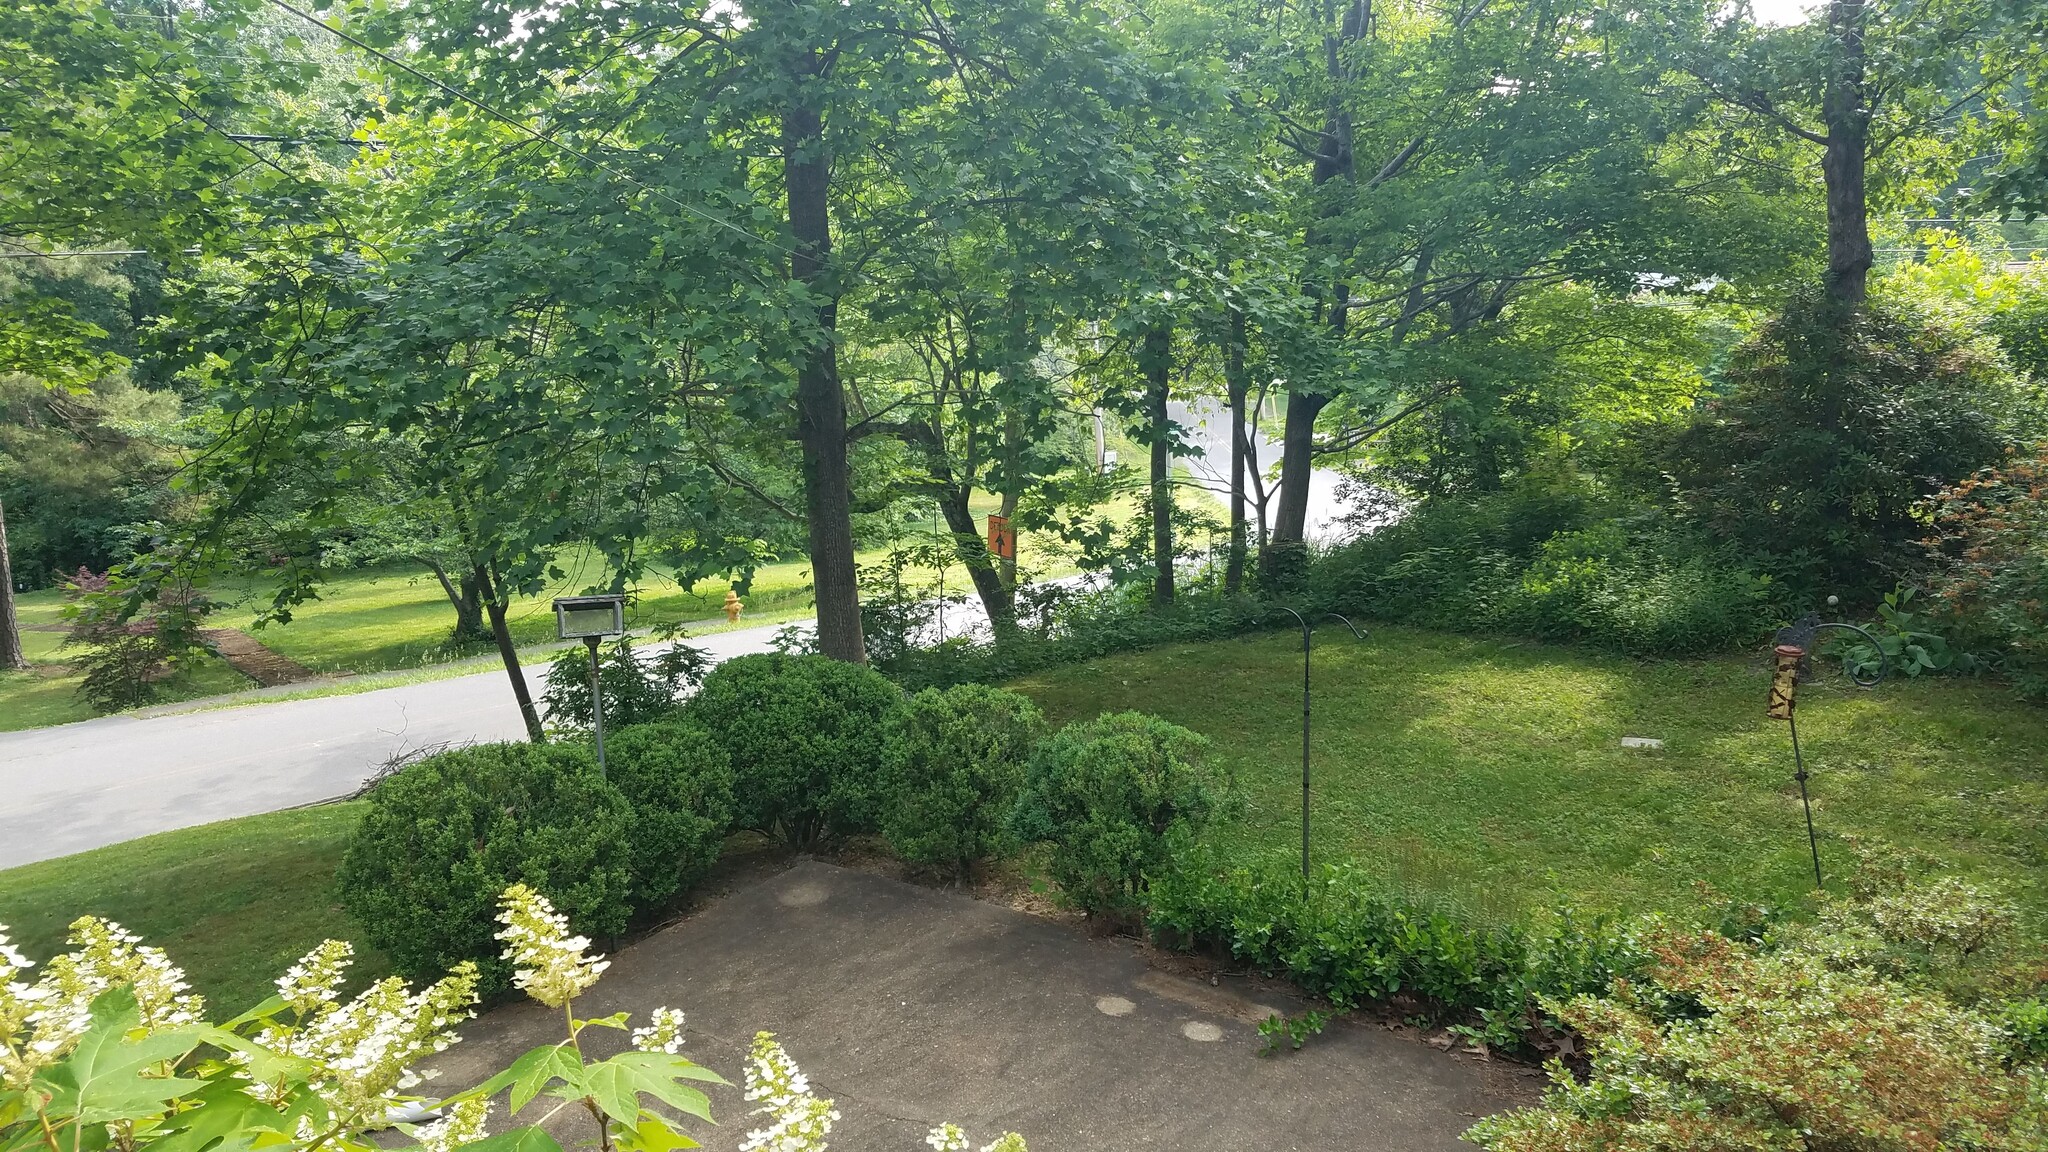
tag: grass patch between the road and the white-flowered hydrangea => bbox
[0,801,387,1019]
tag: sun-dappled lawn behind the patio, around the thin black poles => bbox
[1012,625,2048,937]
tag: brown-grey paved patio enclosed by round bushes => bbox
[436,861,1534,1152]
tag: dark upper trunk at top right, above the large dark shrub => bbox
[1821,0,1872,307]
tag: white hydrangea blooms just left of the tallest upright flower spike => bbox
[258,941,477,1117]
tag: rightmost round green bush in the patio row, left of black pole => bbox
[1012,711,1217,916]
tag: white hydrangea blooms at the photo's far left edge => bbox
[0,916,205,1088]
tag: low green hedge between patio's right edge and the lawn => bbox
[1147,849,1647,1047]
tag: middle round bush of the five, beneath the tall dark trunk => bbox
[684,652,903,847]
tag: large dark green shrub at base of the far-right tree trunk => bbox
[1663,289,2034,603]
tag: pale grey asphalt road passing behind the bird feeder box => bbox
[0,625,780,867]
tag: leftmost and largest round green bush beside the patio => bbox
[338,744,633,992]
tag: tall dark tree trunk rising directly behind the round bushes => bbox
[782,98,868,664]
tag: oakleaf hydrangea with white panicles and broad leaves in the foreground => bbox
[0,883,1026,1152]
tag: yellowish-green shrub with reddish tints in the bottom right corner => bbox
[1466,931,2048,1152]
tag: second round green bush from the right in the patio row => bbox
[883,685,1044,875]
